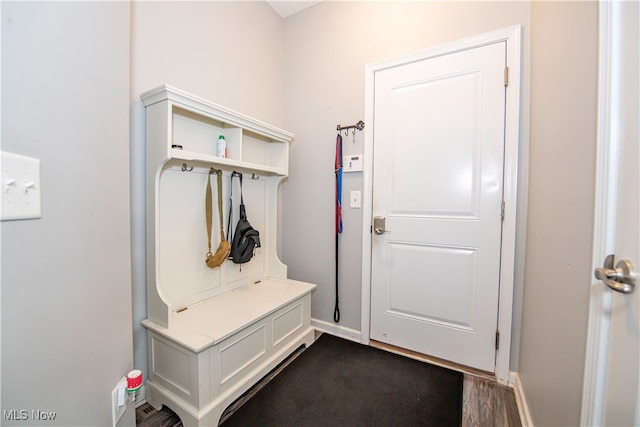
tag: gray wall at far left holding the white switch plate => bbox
[1,2,135,426]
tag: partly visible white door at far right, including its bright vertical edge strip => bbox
[581,2,640,426]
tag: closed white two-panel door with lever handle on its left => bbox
[370,42,506,372]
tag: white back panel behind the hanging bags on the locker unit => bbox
[156,165,271,309]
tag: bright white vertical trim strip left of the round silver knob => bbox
[580,1,622,425]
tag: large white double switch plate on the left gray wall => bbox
[0,152,42,221]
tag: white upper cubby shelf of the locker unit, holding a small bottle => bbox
[140,85,293,176]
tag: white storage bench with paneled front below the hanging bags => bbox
[142,278,316,426]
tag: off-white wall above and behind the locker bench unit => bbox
[130,1,283,378]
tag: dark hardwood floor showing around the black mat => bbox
[136,341,522,427]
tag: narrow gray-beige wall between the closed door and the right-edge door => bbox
[519,2,598,426]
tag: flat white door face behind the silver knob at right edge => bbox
[603,2,640,426]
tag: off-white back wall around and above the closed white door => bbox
[282,1,530,362]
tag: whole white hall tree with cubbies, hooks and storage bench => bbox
[141,85,315,425]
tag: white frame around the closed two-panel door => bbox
[360,25,527,384]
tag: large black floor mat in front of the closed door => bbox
[222,334,463,427]
